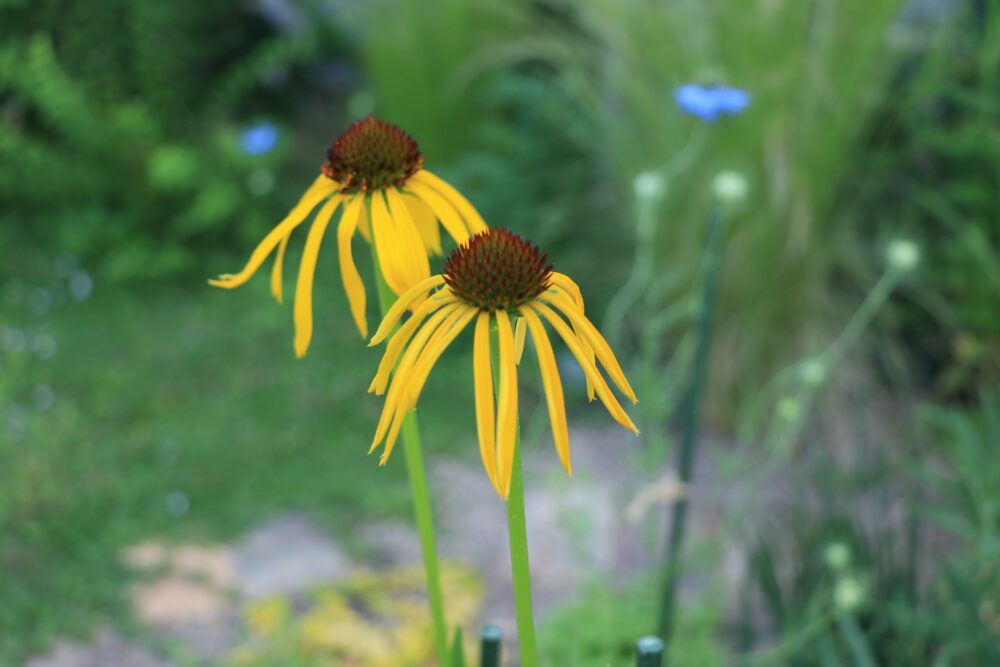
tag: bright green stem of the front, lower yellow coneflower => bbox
[490,321,538,667]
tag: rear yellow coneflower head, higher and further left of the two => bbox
[209,116,486,357]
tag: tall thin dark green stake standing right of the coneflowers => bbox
[659,210,723,652]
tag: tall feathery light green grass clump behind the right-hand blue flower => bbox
[528,0,903,419]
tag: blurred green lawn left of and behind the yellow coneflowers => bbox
[0,253,475,664]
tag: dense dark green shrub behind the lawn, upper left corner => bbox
[0,0,343,281]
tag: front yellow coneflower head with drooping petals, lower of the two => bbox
[369,228,638,499]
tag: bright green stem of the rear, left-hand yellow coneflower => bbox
[372,236,449,667]
